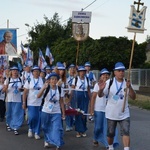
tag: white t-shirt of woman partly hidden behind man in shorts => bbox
[93,83,106,112]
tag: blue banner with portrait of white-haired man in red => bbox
[0,29,17,56]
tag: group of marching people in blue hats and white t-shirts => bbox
[0,62,135,150]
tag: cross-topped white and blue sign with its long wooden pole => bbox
[122,0,147,112]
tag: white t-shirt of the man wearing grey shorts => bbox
[104,78,130,120]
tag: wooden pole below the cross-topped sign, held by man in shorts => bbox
[122,32,136,112]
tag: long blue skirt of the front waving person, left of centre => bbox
[41,112,64,146]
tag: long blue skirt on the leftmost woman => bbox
[6,102,24,130]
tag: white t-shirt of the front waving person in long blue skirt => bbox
[42,87,64,114]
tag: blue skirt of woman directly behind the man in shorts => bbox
[94,111,119,147]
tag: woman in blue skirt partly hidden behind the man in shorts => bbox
[90,68,119,148]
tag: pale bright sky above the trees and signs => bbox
[0,0,150,49]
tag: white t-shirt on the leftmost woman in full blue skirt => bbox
[4,78,22,102]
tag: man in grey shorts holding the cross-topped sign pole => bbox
[98,62,136,150]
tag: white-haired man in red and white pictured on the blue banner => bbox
[0,31,17,56]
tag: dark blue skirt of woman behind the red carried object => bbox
[73,91,89,133]
